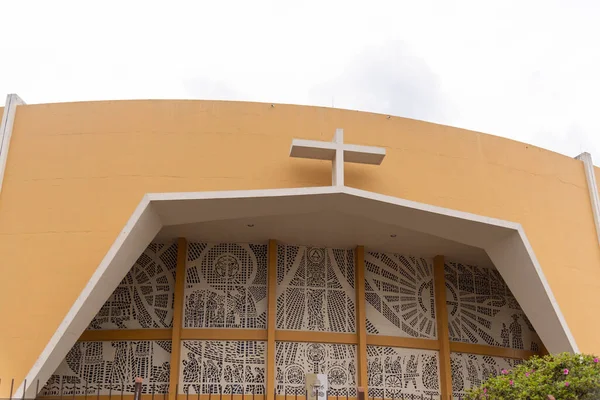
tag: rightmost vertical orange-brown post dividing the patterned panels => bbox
[433,256,452,399]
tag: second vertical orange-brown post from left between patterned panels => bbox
[265,239,277,400]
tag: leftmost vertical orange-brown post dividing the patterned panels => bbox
[169,238,188,400]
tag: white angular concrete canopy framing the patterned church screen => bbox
[16,186,578,398]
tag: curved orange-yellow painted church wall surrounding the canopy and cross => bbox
[0,101,600,392]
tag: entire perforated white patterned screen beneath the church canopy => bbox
[41,242,541,398]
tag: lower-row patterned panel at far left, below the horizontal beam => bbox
[40,340,171,396]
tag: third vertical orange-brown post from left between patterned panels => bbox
[354,246,369,393]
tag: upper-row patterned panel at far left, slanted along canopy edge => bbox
[88,243,177,330]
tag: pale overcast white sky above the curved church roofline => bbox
[0,0,600,161]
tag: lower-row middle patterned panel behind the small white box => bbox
[275,342,357,398]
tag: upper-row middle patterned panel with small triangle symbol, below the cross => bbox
[276,245,356,333]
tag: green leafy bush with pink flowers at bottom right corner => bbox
[465,353,600,400]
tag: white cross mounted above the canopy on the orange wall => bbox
[290,129,385,186]
